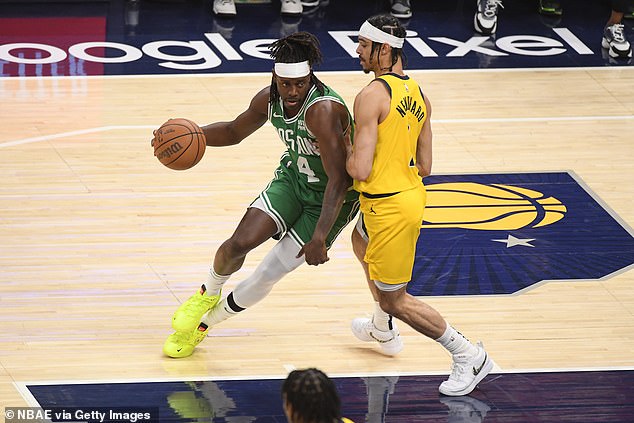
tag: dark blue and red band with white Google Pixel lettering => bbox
[0,0,634,76]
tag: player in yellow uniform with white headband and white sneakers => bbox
[346,15,493,396]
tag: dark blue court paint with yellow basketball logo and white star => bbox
[408,172,634,296]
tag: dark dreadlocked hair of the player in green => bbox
[269,31,325,102]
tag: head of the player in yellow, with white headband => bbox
[356,15,407,73]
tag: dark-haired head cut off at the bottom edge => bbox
[282,368,341,423]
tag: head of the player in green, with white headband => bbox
[269,32,324,117]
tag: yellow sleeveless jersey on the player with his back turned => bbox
[354,73,427,194]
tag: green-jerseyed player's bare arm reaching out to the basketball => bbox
[202,87,269,147]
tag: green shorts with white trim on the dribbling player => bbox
[251,166,359,248]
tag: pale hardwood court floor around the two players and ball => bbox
[0,68,634,407]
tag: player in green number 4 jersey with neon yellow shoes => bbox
[163,32,359,358]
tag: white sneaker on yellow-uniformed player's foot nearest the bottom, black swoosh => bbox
[438,342,493,397]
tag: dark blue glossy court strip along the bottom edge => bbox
[27,370,634,423]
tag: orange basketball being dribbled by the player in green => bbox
[152,119,206,170]
